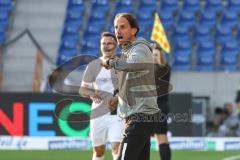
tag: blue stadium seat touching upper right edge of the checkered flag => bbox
[159,10,174,31]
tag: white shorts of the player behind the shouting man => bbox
[90,115,124,147]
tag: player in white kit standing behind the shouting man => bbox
[80,32,124,160]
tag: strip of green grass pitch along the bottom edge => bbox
[0,150,240,160]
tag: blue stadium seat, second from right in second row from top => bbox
[198,10,217,28]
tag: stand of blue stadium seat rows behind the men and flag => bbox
[57,0,240,71]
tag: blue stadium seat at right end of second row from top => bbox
[220,10,239,29]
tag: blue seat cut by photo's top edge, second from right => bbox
[205,0,224,14]
